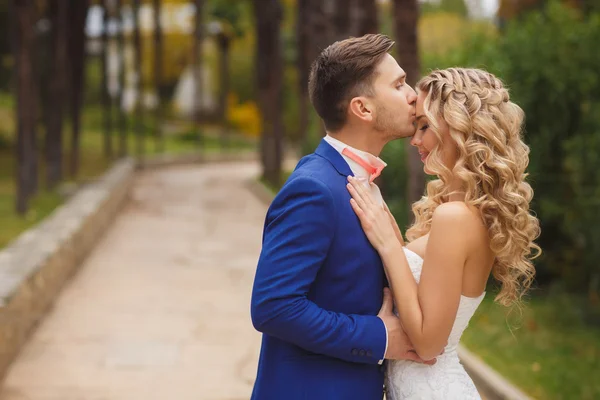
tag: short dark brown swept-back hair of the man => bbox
[308,34,394,132]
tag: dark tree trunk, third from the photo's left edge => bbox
[67,0,89,179]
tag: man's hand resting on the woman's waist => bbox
[377,288,436,365]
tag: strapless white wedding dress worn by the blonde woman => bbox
[385,248,485,400]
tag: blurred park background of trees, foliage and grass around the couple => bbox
[0,0,600,399]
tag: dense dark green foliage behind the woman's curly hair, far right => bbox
[424,2,600,304]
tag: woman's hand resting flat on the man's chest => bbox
[347,176,399,253]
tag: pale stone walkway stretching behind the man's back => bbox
[0,163,266,400]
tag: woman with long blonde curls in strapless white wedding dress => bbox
[348,68,540,400]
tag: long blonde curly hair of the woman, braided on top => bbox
[406,68,541,306]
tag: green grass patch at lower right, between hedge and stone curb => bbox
[462,293,600,400]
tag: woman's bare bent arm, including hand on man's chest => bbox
[348,180,470,360]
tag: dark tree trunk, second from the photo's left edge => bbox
[45,0,69,189]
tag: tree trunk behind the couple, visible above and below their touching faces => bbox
[394,0,425,215]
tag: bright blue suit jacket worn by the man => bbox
[251,140,386,400]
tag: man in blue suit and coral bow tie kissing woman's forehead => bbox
[251,35,422,400]
